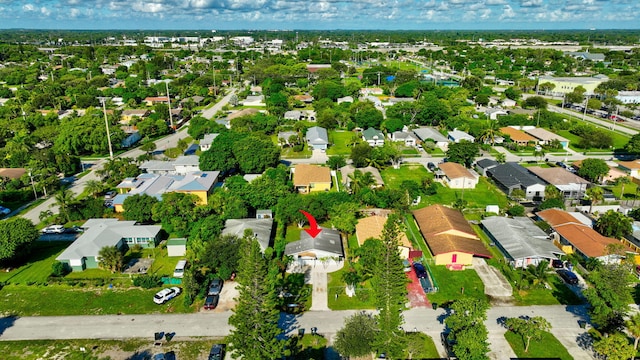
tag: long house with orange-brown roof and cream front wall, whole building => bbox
[413,205,491,268]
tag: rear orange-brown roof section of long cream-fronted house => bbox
[413,205,476,237]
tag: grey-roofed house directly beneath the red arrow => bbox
[284,228,344,264]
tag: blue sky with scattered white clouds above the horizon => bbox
[0,0,640,30]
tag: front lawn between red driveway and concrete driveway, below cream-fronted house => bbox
[427,264,485,305]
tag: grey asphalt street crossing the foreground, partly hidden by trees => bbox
[0,305,593,360]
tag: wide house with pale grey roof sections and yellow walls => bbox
[113,171,220,212]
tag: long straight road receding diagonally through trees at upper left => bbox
[21,88,236,224]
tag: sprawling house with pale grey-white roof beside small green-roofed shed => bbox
[56,219,161,271]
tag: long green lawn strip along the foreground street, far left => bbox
[0,285,193,316]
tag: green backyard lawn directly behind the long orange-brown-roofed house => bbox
[420,177,508,209]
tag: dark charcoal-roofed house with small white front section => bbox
[487,162,546,200]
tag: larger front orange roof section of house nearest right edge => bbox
[554,224,632,257]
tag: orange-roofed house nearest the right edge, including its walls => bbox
[536,209,633,263]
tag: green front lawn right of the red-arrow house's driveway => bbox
[327,266,376,310]
